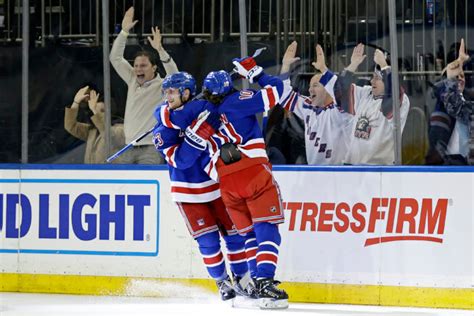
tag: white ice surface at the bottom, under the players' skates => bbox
[0,292,474,316]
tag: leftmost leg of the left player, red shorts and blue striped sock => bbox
[177,203,235,301]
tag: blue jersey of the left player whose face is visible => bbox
[153,100,220,203]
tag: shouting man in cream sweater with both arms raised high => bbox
[110,7,178,164]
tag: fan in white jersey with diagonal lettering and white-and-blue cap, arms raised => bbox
[280,41,353,165]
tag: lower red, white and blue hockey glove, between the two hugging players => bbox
[185,110,221,150]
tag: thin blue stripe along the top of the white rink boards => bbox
[0,164,474,173]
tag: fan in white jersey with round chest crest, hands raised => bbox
[335,44,410,165]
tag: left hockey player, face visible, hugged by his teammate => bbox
[153,72,251,300]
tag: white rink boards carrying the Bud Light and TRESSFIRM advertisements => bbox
[0,165,474,308]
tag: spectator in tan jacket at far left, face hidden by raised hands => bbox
[64,86,125,164]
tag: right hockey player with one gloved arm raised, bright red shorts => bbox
[197,57,288,309]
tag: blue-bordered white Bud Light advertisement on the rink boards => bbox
[0,179,160,256]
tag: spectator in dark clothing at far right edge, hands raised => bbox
[426,39,474,165]
